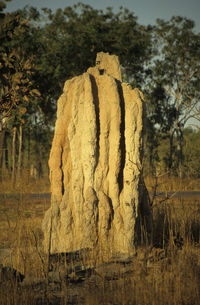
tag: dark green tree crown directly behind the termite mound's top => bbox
[22,4,151,104]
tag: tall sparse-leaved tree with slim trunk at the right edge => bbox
[150,17,200,176]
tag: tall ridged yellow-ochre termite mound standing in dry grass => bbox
[43,52,151,255]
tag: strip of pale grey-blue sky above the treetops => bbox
[6,0,200,32]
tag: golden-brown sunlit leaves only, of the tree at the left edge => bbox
[0,14,40,121]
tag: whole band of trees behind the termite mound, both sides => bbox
[0,1,200,184]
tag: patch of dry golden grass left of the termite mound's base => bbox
[0,194,50,276]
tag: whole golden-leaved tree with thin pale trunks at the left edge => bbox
[0,5,40,183]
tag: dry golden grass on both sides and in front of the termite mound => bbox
[0,179,200,305]
